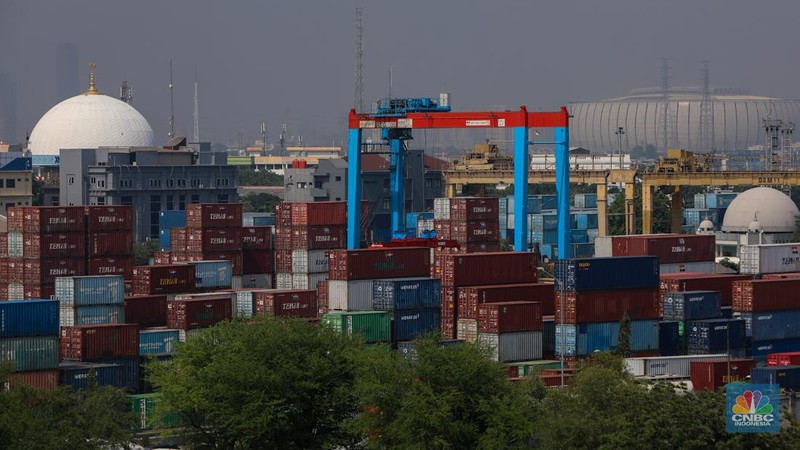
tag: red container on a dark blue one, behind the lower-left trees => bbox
[60,324,139,391]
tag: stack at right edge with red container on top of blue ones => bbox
[733,278,800,361]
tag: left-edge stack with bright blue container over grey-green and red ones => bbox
[0,300,59,388]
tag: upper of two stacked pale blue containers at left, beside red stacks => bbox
[56,275,125,306]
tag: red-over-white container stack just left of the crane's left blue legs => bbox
[275,202,347,289]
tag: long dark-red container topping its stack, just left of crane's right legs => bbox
[442,252,539,287]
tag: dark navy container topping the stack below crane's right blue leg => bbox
[555,256,660,292]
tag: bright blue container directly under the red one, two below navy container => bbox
[555,320,659,356]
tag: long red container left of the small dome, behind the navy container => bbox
[611,234,716,264]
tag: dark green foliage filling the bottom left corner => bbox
[0,364,135,449]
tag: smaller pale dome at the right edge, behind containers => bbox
[722,187,800,233]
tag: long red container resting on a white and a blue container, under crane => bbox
[328,247,431,280]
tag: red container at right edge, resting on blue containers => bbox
[733,278,800,312]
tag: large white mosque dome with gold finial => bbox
[28,66,155,155]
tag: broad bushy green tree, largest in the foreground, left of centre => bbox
[151,317,361,449]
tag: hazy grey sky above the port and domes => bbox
[0,0,800,145]
